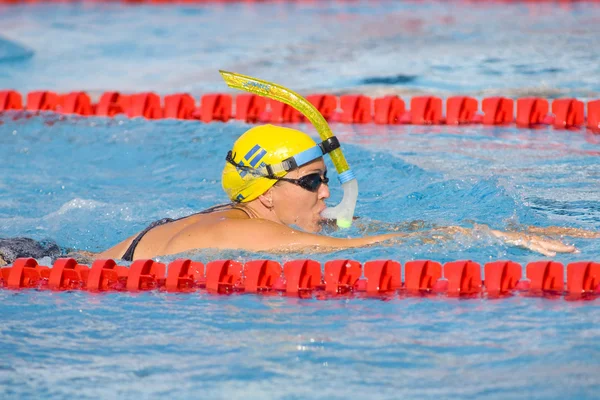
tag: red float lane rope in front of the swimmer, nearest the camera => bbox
[0,258,600,300]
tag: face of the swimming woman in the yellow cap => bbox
[272,158,329,232]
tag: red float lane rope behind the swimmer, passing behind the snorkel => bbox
[0,90,600,133]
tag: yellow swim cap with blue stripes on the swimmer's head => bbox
[221,125,322,203]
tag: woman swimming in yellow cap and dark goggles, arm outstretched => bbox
[97,125,575,261]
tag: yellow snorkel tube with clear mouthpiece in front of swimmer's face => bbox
[219,70,358,228]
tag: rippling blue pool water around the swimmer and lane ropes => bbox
[0,1,600,399]
